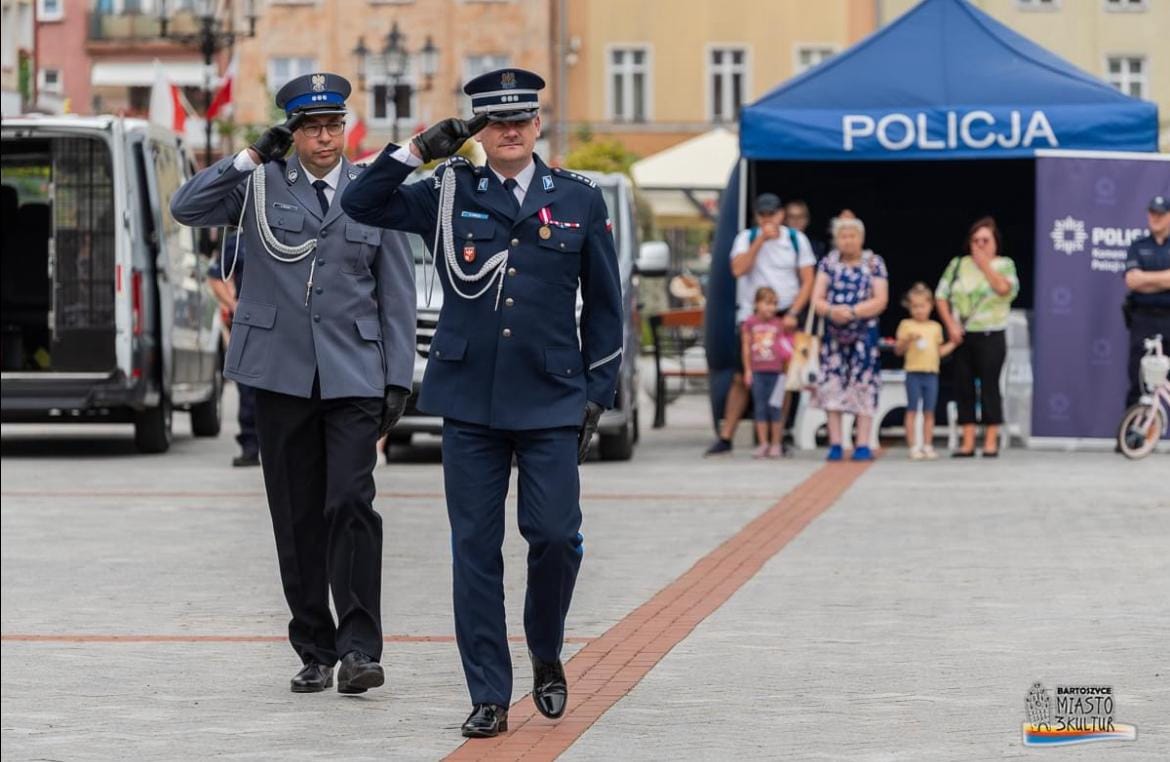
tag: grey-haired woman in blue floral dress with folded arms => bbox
[812,218,889,460]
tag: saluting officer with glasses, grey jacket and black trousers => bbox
[171,74,415,693]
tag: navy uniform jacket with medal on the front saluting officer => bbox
[342,145,622,430]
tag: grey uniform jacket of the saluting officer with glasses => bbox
[171,156,417,399]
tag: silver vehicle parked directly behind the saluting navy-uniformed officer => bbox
[390,172,669,460]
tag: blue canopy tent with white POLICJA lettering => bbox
[707,0,1158,428]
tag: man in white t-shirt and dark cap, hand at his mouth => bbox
[706,193,817,455]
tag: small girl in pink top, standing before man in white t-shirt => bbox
[742,286,792,458]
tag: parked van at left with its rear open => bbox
[0,116,223,452]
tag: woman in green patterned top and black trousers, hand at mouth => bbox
[935,217,1020,458]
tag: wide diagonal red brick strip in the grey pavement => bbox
[447,462,868,760]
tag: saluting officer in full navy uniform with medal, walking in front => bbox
[342,69,622,737]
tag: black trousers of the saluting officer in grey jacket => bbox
[256,384,383,666]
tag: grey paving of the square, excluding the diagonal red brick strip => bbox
[0,383,1170,760]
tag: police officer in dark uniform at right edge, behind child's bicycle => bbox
[1126,195,1170,407]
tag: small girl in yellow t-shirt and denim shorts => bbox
[894,283,955,460]
